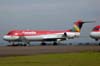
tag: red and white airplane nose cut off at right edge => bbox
[90,25,100,41]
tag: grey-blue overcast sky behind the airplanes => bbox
[0,0,100,42]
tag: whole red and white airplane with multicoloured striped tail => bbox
[3,20,94,45]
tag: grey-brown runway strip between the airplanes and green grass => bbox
[0,45,100,57]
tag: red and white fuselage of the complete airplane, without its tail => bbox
[3,30,80,41]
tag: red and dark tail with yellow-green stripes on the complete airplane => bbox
[71,20,95,32]
